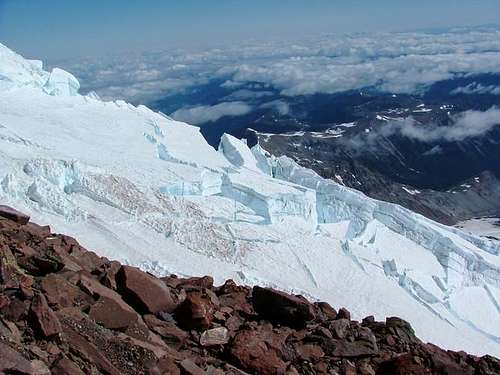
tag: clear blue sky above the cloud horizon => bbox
[0,0,500,61]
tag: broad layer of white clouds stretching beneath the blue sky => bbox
[60,28,500,103]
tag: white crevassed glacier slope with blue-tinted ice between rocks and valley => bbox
[0,44,500,356]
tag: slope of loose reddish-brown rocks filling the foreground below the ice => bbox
[0,206,500,375]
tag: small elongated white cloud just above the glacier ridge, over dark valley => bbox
[170,102,252,125]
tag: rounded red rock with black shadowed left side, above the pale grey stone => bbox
[175,292,213,330]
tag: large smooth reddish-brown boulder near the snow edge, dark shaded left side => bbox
[116,266,176,314]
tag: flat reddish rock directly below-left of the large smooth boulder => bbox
[89,297,138,330]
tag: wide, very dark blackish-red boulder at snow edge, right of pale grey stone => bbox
[252,286,315,326]
